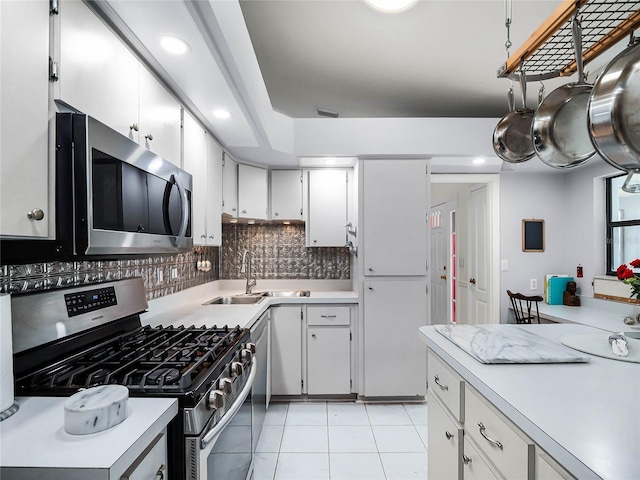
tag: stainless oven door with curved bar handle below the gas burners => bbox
[192,357,258,480]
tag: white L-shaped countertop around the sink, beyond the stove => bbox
[141,282,358,328]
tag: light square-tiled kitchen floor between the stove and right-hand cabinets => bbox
[254,402,427,480]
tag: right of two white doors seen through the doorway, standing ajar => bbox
[468,186,491,324]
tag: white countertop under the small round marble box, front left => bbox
[0,397,178,478]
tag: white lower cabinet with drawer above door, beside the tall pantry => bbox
[307,306,351,395]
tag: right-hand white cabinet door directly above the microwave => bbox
[138,64,181,166]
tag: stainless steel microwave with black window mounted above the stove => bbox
[56,113,193,256]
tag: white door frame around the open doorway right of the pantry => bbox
[431,173,500,323]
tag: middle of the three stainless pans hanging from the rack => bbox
[532,11,595,168]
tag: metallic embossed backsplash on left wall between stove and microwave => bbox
[0,247,220,300]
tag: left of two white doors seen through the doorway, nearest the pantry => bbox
[429,200,457,325]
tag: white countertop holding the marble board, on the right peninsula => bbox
[420,322,640,480]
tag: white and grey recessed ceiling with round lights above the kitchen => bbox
[95,0,632,173]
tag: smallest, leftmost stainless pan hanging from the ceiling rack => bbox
[493,71,536,163]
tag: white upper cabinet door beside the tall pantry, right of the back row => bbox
[306,170,348,247]
